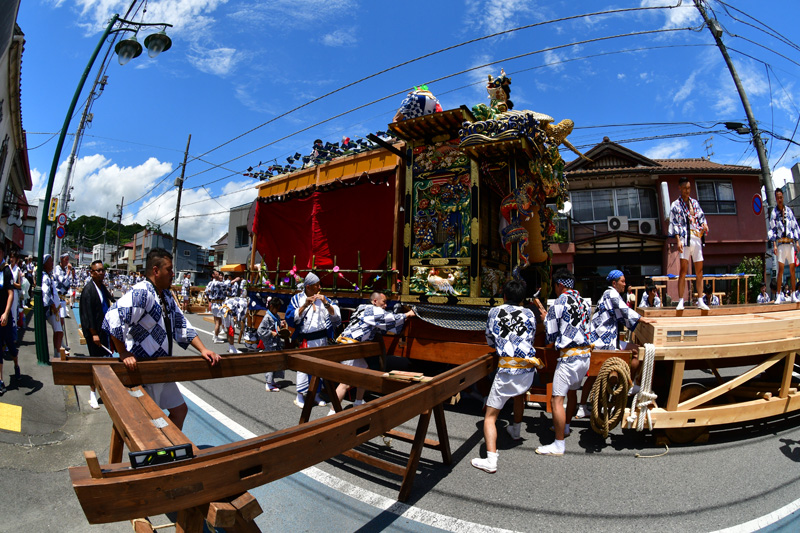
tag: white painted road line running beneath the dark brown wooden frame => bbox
[178,382,514,533]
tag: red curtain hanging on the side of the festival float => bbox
[253,179,394,271]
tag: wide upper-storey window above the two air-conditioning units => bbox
[570,187,658,222]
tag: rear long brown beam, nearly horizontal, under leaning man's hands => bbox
[50,342,381,387]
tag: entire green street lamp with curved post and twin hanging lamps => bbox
[33,14,172,365]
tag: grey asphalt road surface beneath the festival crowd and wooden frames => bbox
[0,308,800,532]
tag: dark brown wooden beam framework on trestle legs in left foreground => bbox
[51,342,496,532]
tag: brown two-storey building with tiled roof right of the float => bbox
[553,137,767,298]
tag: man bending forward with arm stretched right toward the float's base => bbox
[328,291,414,415]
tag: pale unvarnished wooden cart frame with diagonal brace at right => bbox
[634,303,800,440]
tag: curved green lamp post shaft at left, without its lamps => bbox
[33,15,119,365]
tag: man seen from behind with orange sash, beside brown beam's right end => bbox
[472,280,542,474]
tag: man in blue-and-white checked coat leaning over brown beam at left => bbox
[102,248,220,429]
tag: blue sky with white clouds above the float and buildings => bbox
[17,0,800,245]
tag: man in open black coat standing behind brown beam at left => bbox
[79,260,114,409]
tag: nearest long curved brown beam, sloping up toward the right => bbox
[70,354,493,524]
